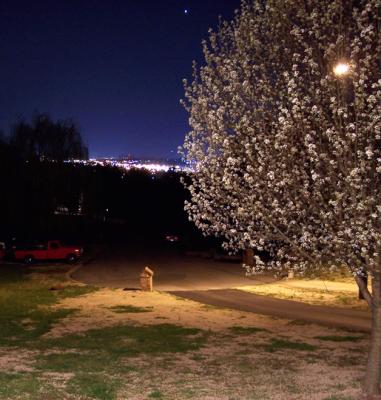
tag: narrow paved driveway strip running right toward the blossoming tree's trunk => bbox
[170,289,371,332]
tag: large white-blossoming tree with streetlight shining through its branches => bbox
[182,0,381,398]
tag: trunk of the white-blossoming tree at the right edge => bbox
[364,271,381,400]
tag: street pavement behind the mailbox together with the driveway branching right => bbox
[72,248,371,332]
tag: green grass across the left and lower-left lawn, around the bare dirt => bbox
[0,266,207,400]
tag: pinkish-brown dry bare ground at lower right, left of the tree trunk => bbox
[114,334,361,400]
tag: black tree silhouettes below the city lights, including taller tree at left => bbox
[0,114,195,240]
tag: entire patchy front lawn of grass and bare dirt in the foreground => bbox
[0,264,369,400]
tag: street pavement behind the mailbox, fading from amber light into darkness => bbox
[72,247,274,291]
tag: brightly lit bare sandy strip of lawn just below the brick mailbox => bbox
[49,289,289,336]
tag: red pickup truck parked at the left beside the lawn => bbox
[13,240,83,264]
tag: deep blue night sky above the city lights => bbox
[0,0,240,157]
